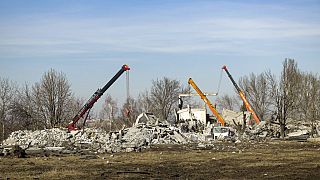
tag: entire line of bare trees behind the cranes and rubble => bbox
[0,59,320,140]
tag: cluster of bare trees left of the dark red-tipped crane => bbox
[0,69,81,140]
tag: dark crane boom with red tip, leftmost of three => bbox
[67,64,130,132]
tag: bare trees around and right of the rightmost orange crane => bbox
[219,59,320,137]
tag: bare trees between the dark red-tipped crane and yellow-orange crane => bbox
[96,77,190,130]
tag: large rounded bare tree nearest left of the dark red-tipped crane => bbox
[33,69,72,128]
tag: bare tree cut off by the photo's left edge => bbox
[0,77,17,140]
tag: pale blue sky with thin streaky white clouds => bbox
[0,0,320,109]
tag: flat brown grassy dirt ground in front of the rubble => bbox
[0,141,320,179]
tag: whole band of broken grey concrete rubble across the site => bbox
[0,110,320,155]
